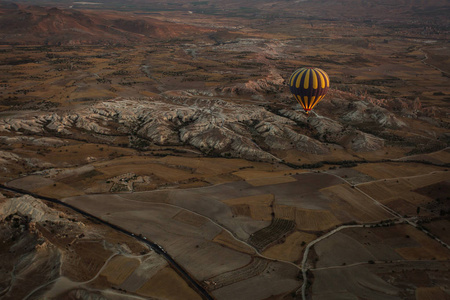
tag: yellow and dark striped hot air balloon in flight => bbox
[288,68,330,114]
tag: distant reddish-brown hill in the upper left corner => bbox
[0,2,210,45]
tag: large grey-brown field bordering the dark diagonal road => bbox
[62,195,256,280]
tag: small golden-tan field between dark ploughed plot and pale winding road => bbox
[262,231,316,262]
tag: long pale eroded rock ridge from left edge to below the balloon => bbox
[0,97,327,161]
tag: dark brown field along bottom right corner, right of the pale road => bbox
[312,261,449,300]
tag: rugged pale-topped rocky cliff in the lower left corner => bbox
[0,196,67,299]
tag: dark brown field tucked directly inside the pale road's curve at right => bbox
[314,225,450,274]
